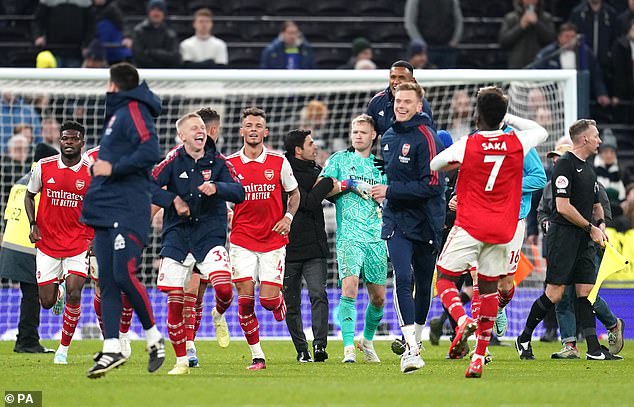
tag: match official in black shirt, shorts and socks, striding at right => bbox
[515,119,623,360]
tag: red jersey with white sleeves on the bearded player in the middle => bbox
[227,148,297,252]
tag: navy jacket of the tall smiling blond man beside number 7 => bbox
[381,113,446,249]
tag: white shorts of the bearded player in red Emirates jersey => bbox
[229,244,286,287]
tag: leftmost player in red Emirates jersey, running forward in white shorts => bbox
[24,121,93,365]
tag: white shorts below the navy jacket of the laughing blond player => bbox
[156,246,231,291]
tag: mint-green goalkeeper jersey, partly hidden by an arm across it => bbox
[320,150,387,243]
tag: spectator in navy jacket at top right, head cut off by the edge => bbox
[569,0,619,73]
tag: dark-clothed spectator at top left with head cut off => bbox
[35,0,95,68]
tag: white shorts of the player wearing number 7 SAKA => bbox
[436,226,508,281]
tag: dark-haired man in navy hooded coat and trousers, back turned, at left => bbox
[82,62,165,378]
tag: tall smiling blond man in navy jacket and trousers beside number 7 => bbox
[372,82,446,373]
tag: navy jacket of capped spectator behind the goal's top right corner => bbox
[533,42,608,97]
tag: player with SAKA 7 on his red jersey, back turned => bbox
[431,87,548,378]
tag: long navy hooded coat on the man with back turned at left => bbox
[81,82,161,244]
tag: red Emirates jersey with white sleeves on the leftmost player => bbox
[28,154,94,258]
